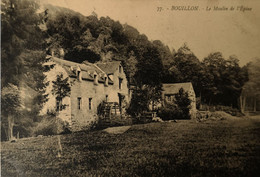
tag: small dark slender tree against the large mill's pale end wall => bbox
[52,74,71,112]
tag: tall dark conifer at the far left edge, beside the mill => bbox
[1,0,46,138]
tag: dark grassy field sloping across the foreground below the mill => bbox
[1,117,260,177]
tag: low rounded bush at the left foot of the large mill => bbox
[33,116,69,136]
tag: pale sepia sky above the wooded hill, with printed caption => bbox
[41,0,260,66]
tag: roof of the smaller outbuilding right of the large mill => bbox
[162,82,193,94]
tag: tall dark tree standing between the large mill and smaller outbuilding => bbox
[128,44,162,116]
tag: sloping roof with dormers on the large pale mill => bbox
[47,56,113,84]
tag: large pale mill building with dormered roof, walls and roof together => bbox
[42,56,130,131]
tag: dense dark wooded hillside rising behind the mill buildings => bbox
[44,6,248,110]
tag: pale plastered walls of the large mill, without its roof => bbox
[41,63,129,131]
